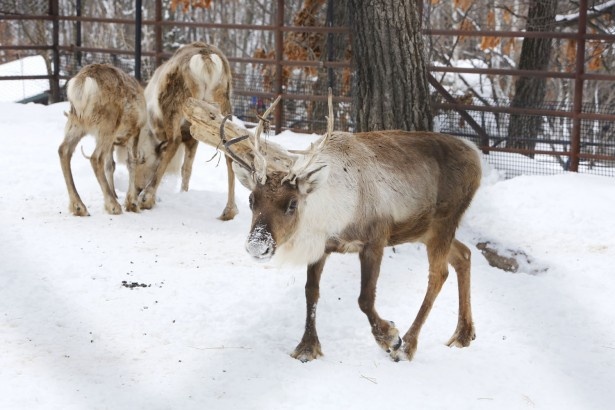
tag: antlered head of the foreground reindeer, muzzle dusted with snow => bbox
[230,94,333,261]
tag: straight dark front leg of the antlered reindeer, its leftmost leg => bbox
[291,254,328,363]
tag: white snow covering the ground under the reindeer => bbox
[0,103,615,410]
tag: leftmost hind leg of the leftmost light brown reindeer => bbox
[58,120,90,216]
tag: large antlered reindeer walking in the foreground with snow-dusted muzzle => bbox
[185,95,481,362]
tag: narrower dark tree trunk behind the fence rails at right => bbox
[507,0,557,158]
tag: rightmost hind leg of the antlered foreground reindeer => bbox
[447,239,476,347]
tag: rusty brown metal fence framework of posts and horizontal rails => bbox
[0,0,615,172]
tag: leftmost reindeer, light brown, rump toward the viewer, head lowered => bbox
[58,64,146,216]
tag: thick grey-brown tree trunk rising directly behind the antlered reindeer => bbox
[348,0,433,132]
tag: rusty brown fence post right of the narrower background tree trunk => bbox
[568,0,587,172]
